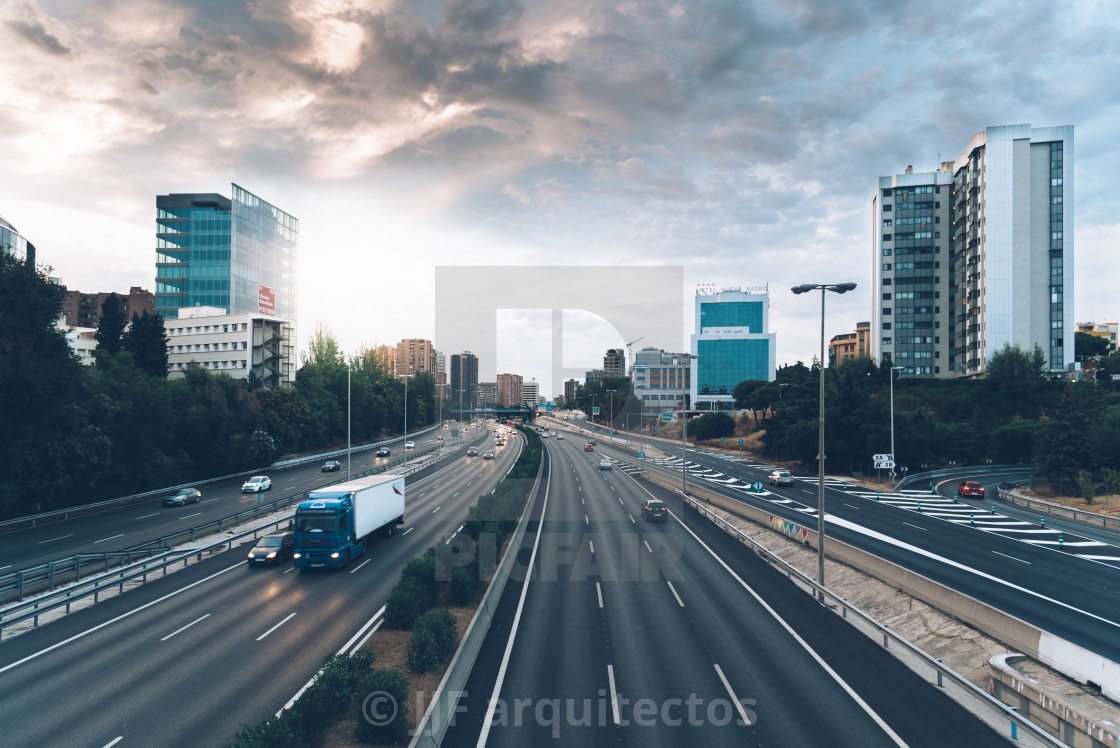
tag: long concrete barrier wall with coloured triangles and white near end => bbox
[646,471,1120,701]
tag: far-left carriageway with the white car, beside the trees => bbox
[0,431,459,574]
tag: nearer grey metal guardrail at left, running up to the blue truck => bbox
[0,516,291,638]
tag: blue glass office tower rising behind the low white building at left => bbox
[156,185,299,320]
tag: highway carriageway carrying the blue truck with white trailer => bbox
[0,423,523,747]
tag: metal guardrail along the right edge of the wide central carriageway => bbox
[674,490,1066,748]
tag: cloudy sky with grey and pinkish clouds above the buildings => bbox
[0,0,1120,394]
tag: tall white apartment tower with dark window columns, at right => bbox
[871,124,1074,377]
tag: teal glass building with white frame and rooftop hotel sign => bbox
[690,287,776,410]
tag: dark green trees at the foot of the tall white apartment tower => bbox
[730,346,1120,493]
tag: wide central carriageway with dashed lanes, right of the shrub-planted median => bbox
[444,439,998,747]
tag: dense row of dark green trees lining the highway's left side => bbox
[0,254,438,518]
